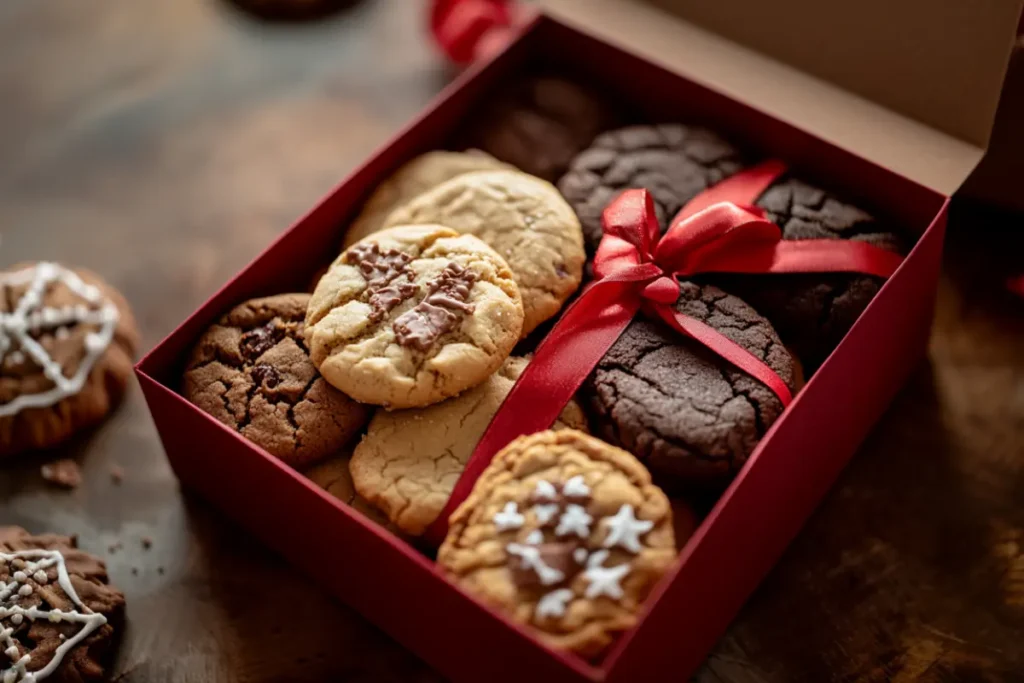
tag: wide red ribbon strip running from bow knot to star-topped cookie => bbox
[424,281,640,546]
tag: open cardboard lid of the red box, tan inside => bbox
[535,0,1024,195]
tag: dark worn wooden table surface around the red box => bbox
[0,0,1024,683]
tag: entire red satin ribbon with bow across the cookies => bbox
[427,161,901,543]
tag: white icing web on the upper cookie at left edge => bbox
[0,262,118,417]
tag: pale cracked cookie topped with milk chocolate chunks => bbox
[305,225,522,409]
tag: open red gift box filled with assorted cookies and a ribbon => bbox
[137,0,1020,681]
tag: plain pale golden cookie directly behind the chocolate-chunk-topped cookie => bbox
[386,171,586,336]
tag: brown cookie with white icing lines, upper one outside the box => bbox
[0,262,138,458]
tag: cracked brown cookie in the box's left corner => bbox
[184,294,370,467]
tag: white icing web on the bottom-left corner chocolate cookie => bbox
[0,548,106,683]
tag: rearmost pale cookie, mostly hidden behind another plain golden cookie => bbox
[345,150,511,247]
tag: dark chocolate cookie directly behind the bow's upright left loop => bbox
[558,124,743,253]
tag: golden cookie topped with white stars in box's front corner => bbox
[437,429,676,659]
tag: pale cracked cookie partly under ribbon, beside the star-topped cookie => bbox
[350,357,587,536]
